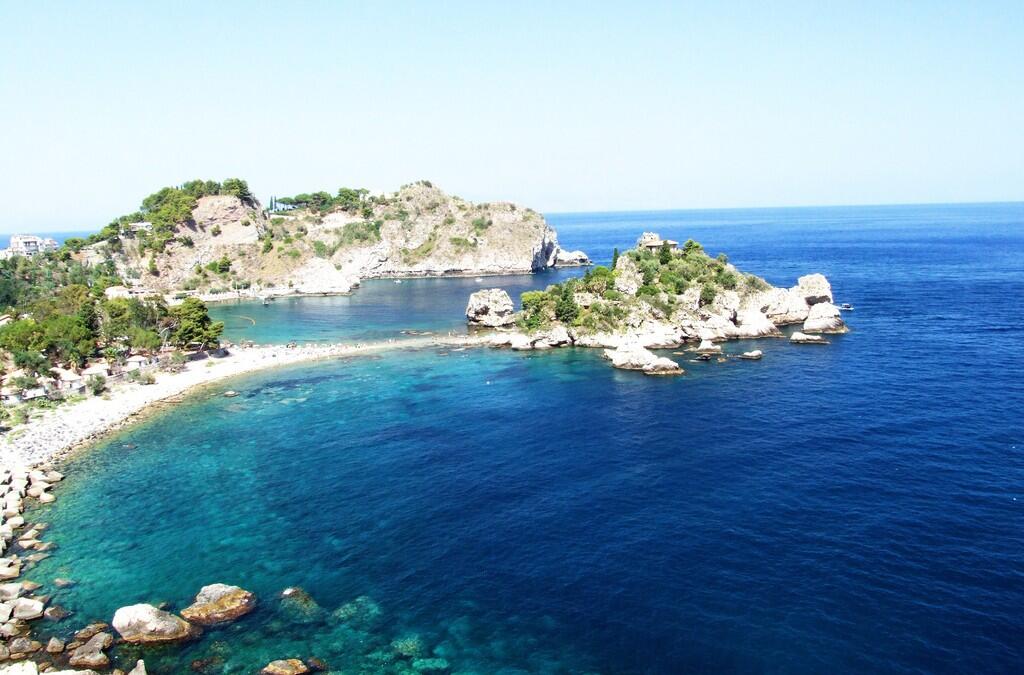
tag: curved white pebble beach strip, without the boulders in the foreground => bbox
[0,335,486,469]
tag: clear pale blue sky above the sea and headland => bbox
[0,0,1024,231]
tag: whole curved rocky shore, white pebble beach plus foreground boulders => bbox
[0,336,503,675]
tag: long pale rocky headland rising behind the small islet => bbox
[79,181,589,296]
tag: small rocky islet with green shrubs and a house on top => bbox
[466,233,847,375]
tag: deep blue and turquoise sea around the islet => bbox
[24,204,1024,674]
